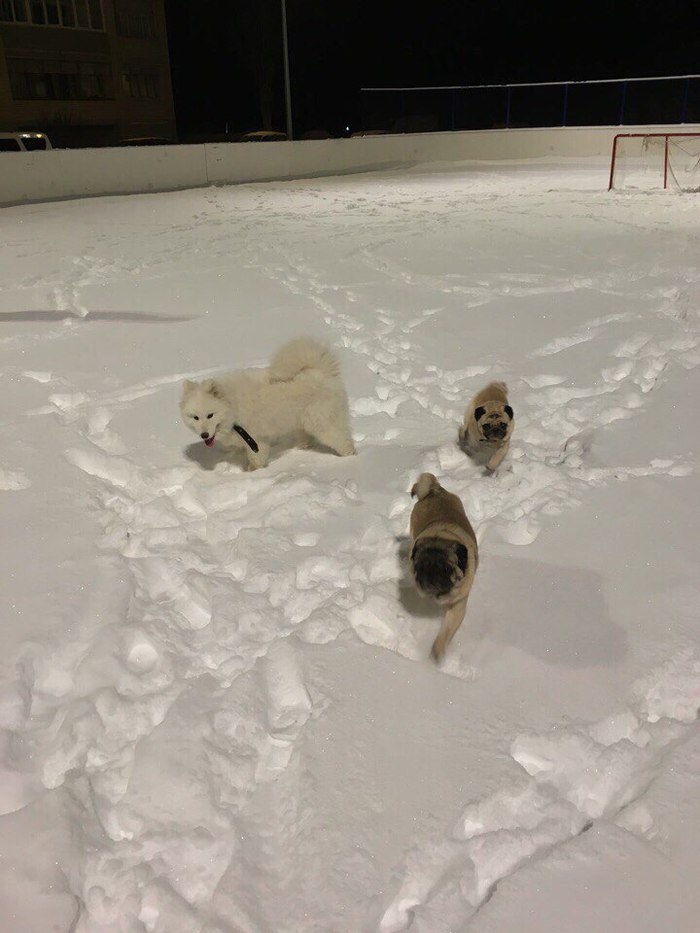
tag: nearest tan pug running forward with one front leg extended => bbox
[410,473,479,661]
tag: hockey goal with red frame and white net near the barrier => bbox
[608,133,700,191]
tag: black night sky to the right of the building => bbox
[166,0,700,138]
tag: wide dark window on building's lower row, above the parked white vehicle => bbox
[7,59,113,100]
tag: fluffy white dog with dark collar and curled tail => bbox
[180,337,355,470]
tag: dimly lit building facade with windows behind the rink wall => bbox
[0,0,176,146]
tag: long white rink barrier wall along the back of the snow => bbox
[0,124,700,205]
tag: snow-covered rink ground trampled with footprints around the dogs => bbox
[0,163,700,933]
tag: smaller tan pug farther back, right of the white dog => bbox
[459,382,515,473]
